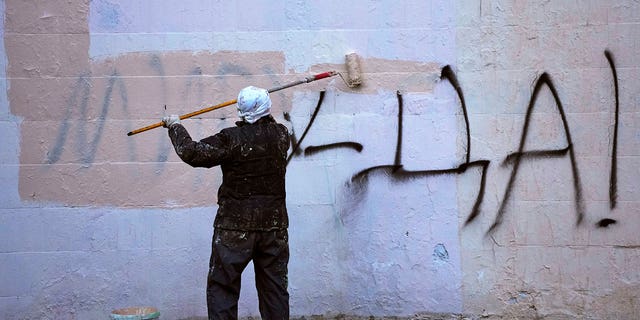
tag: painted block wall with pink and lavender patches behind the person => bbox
[0,0,640,319]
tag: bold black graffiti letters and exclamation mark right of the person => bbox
[285,51,619,235]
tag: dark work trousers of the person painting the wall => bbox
[207,228,289,320]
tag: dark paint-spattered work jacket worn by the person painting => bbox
[169,115,290,231]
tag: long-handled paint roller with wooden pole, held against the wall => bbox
[127,53,362,136]
